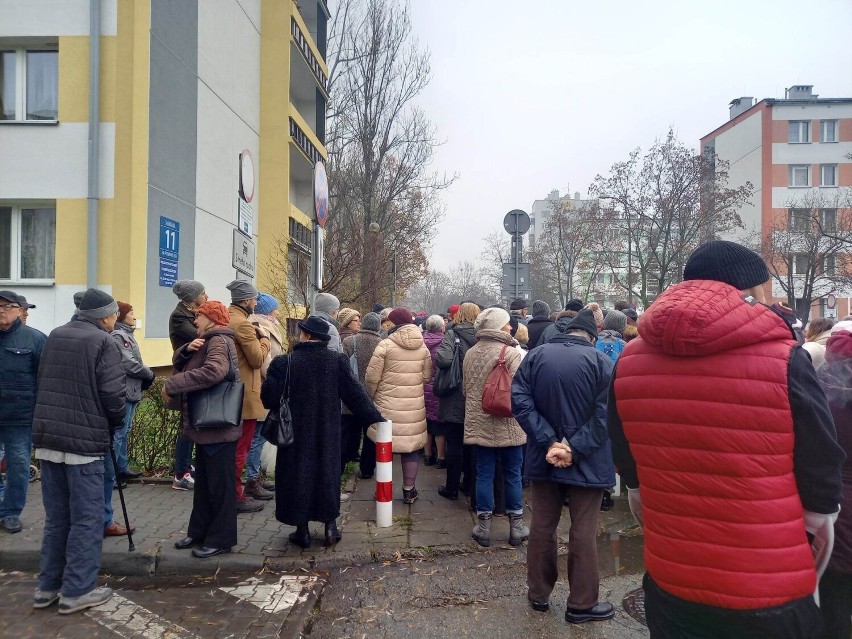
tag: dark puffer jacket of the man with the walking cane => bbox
[33,318,127,457]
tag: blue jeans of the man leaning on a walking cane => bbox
[38,459,104,597]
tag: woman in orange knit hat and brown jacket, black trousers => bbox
[163,300,242,558]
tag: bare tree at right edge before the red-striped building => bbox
[756,189,852,322]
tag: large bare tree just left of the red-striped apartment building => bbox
[589,130,753,306]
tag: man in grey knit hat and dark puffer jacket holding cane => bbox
[33,288,126,614]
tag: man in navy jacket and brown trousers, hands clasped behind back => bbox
[512,309,615,623]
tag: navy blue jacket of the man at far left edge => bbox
[0,319,47,428]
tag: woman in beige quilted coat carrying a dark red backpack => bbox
[462,308,530,546]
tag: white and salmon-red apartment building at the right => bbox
[700,85,852,317]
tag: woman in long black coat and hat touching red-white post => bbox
[260,317,383,548]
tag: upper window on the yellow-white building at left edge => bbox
[0,49,59,122]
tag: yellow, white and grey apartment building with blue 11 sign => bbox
[0,0,329,366]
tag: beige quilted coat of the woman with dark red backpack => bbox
[462,329,527,448]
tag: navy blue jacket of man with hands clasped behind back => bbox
[512,333,615,488]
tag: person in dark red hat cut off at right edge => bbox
[818,330,852,639]
